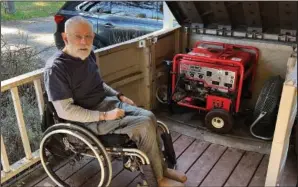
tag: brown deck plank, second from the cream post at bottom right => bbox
[225,152,263,186]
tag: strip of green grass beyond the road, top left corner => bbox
[1,1,64,21]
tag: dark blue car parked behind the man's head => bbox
[54,1,163,49]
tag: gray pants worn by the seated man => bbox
[86,97,167,180]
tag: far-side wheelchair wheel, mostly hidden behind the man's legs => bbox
[157,121,177,169]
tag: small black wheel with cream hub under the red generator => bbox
[205,109,234,134]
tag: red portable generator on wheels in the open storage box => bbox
[169,41,259,133]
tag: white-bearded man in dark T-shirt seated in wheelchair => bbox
[44,16,187,186]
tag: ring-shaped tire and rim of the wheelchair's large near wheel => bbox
[40,123,112,186]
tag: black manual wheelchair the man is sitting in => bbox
[40,94,176,187]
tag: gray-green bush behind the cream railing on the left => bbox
[0,35,42,164]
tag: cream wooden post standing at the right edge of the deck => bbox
[265,58,297,187]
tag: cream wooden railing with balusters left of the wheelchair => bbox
[1,69,44,184]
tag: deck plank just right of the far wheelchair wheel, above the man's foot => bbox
[177,140,210,172]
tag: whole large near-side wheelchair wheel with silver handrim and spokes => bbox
[40,124,112,186]
